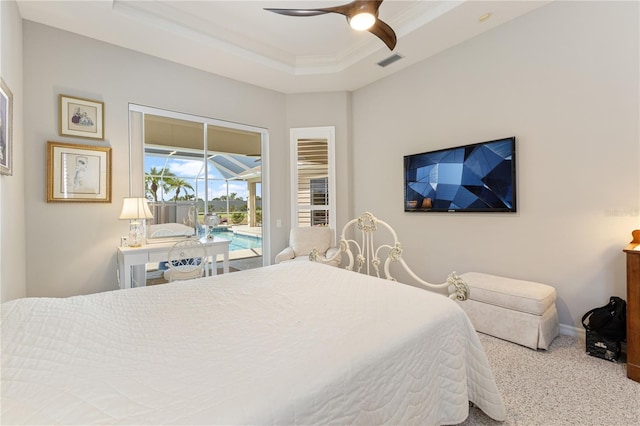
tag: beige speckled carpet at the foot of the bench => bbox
[462,334,640,426]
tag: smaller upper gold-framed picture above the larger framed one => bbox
[58,95,104,140]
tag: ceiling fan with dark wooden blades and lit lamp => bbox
[264,0,397,50]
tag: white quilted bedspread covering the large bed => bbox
[1,262,505,425]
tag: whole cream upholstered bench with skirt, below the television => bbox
[460,272,560,349]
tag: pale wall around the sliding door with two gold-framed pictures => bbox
[22,21,288,296]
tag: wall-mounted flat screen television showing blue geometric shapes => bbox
[404,137,516,212]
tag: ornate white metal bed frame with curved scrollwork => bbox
[309,212,469,300]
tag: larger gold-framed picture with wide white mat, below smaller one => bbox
[47,141,111,203]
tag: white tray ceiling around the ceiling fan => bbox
[17,0,549,93]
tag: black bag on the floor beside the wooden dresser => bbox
[582,296,627,342]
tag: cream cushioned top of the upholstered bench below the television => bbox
[460,272,556,315]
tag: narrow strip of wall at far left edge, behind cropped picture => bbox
[0,1,27,302]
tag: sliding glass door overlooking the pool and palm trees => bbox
[130,105,269,264]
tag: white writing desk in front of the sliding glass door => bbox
[118,238,229,288]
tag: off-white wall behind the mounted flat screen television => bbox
[353,2,640,326]
